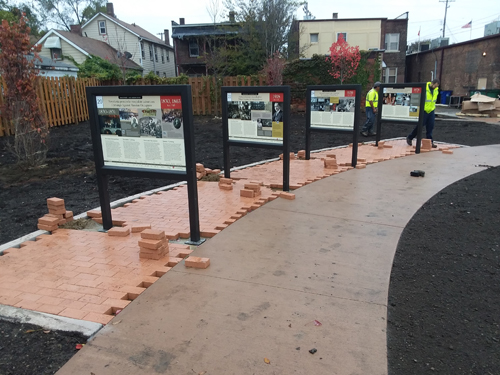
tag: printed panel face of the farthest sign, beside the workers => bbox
[382,87,422,123]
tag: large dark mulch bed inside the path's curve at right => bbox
[387,168,500,375]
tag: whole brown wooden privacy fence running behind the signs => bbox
[0,76,266,137]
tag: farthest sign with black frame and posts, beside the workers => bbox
[375,83,426,154]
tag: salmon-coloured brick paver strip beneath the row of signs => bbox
[0,140,458,324]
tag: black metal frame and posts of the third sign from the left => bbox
[306,85,362,167]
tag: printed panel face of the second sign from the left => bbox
[227,92,284,145]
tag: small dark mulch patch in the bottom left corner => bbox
[0,320,87,375]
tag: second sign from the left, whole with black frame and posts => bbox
[221,86,290,191]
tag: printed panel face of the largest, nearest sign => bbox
[97,96,186,171]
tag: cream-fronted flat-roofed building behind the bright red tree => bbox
[291,13,408,83]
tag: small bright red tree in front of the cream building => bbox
[328,34,361,84]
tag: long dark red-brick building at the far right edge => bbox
[406,34,500,96]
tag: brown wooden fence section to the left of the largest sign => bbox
[0,77,99,136]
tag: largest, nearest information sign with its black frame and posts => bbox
[86,85,204,245]
